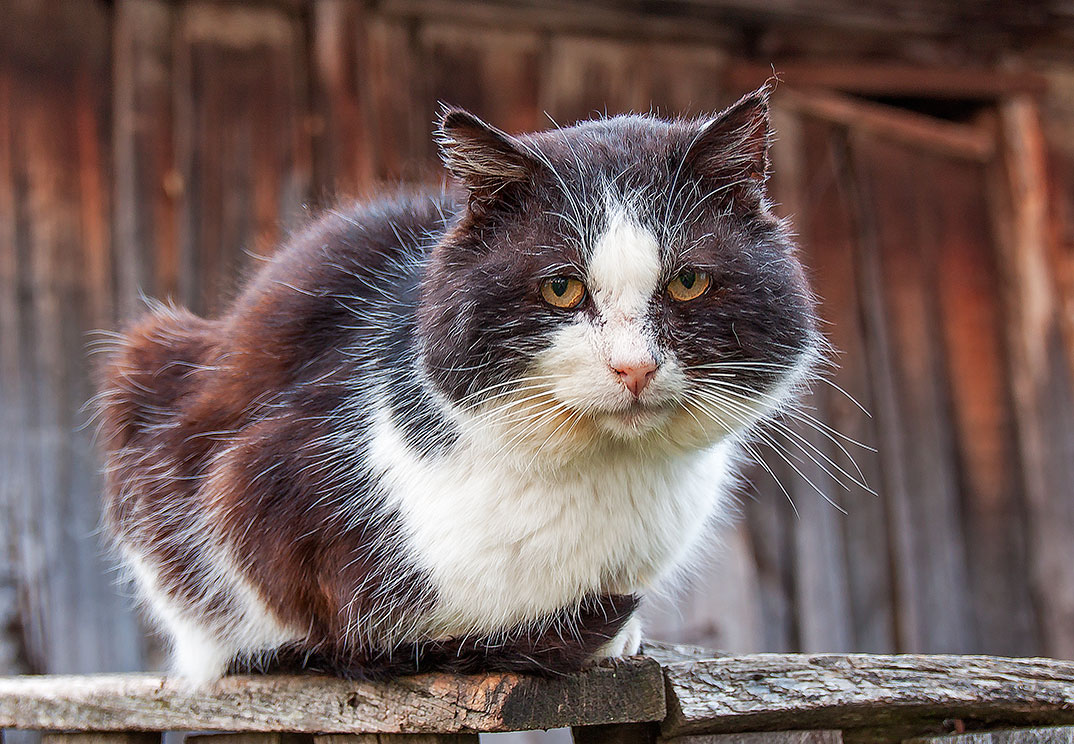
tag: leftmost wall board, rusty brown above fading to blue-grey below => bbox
[0,1,141,672]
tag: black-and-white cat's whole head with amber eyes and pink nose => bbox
[419,87,819,453]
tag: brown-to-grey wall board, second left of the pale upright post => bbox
[852,136,977,653]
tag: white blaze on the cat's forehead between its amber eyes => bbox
[589,205,661,320]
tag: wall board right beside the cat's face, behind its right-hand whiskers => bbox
[773,107,896,652]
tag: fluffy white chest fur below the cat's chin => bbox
[371,415,730,634]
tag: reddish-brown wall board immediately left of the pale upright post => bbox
[930,153,1043,656]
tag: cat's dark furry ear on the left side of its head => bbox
[436,107,538,211]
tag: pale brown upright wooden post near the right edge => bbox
[991,98,1074,658]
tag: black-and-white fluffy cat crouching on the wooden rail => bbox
[101,86,822,684]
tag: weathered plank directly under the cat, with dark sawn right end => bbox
[0,658,664,733]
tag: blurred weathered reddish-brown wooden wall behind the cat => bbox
[0,0,1074,673]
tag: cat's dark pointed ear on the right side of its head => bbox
[685,82,774,195]
